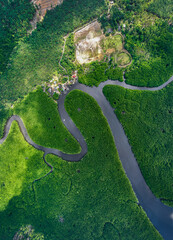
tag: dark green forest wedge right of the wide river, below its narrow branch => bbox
[103,84,173,206]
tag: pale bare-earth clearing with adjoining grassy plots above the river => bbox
[74,21,131,67]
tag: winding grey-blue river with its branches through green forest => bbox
[0,76,173,240]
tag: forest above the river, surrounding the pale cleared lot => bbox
[0,0,173,131]
